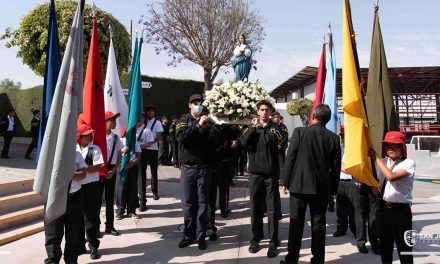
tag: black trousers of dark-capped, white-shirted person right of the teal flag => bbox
[138,149,159,205]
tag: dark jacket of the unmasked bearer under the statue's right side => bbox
[240,121,281,177]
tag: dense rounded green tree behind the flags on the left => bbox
[0,0,131,76]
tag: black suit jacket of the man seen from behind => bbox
[281,123,341,195]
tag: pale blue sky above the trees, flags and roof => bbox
[0,0,440,91]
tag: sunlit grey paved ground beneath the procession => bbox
[0,143,440,264]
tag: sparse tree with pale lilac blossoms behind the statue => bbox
[141,0,265,91]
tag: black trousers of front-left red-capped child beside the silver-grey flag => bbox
[80,181,100,248]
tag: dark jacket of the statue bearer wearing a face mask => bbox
[176,114,209,166]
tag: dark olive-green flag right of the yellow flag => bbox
[366,7,399,155]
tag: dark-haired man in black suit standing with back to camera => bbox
[280,104,341,263]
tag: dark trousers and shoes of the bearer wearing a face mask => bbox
[180,165,208,241]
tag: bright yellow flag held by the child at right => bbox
[342,0,378,187]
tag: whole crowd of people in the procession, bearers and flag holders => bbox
[2,94,415,263]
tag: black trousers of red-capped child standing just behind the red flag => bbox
[98,164,117,227]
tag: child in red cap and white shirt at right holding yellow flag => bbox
[369,131,416,263]
